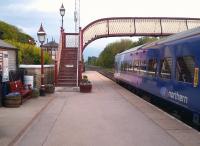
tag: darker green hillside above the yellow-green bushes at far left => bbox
[0,21,33,43]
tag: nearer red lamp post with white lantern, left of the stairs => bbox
[37,24,46,96]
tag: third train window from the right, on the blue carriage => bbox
[147,58,157,76]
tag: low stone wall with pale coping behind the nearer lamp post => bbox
[19,65,54,88]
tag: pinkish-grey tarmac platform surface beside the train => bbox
[0,71,200,146]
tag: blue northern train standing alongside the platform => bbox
[114,27,200,124]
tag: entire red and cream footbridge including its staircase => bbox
[57,17,200,86]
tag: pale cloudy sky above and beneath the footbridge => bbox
[0,0,200,58]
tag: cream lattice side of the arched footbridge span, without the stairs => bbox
[82,17,200,51]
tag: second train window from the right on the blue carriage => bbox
[159,57,172,79]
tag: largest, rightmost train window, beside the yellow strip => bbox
[176,56,195,83]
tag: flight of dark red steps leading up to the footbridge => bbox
[57,48,77,87]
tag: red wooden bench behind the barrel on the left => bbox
[9,80,32,102]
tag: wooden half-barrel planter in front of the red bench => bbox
[3,92,22,107]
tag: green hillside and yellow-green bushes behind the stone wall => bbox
[0,21,52,64]
